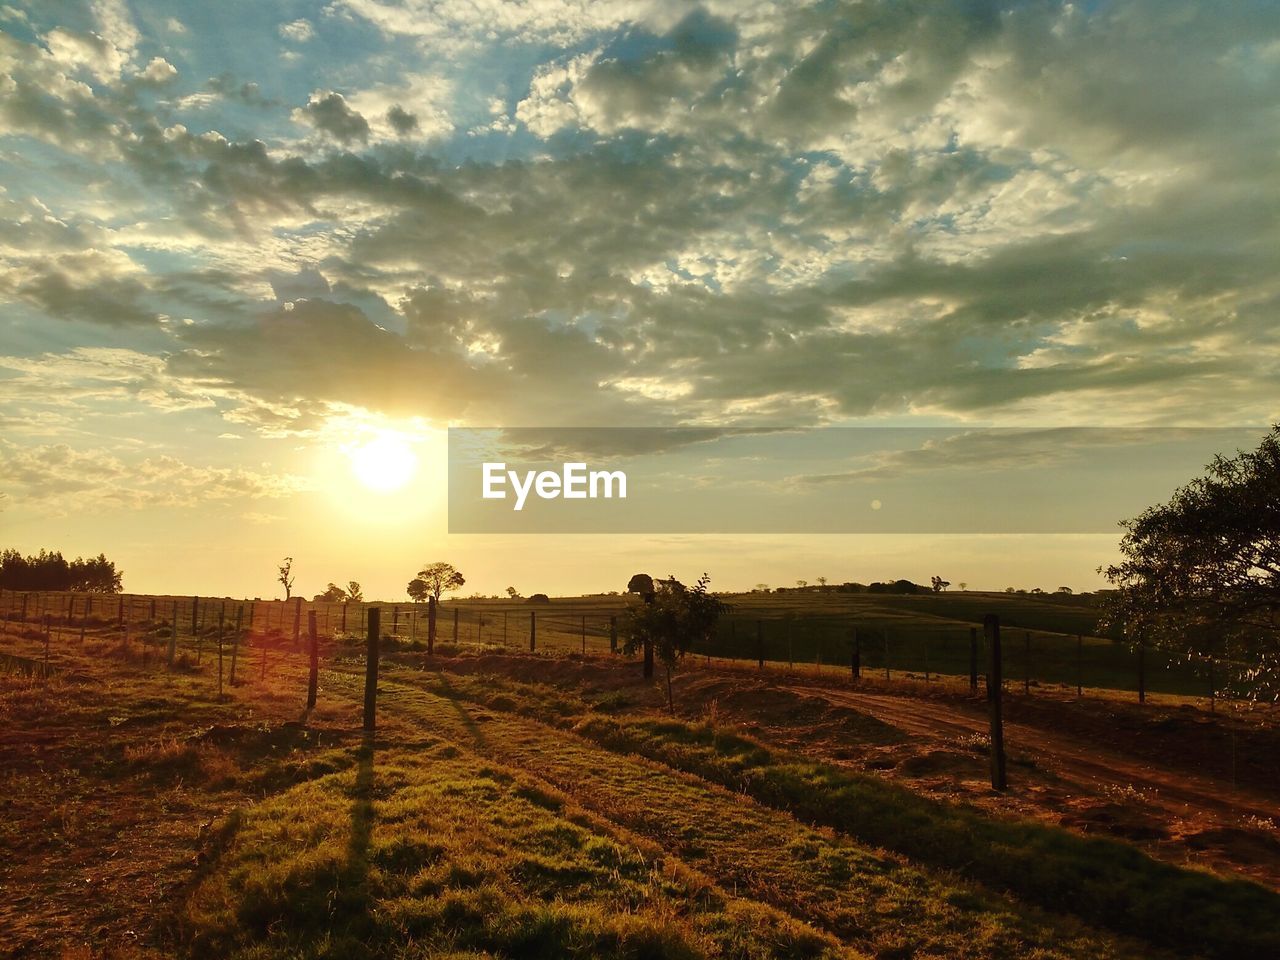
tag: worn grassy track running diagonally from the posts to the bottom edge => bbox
[322,673,1165,960]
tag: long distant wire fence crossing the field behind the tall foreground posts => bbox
[0,590,1254,703]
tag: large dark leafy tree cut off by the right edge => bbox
[1103,424,1280,699]
